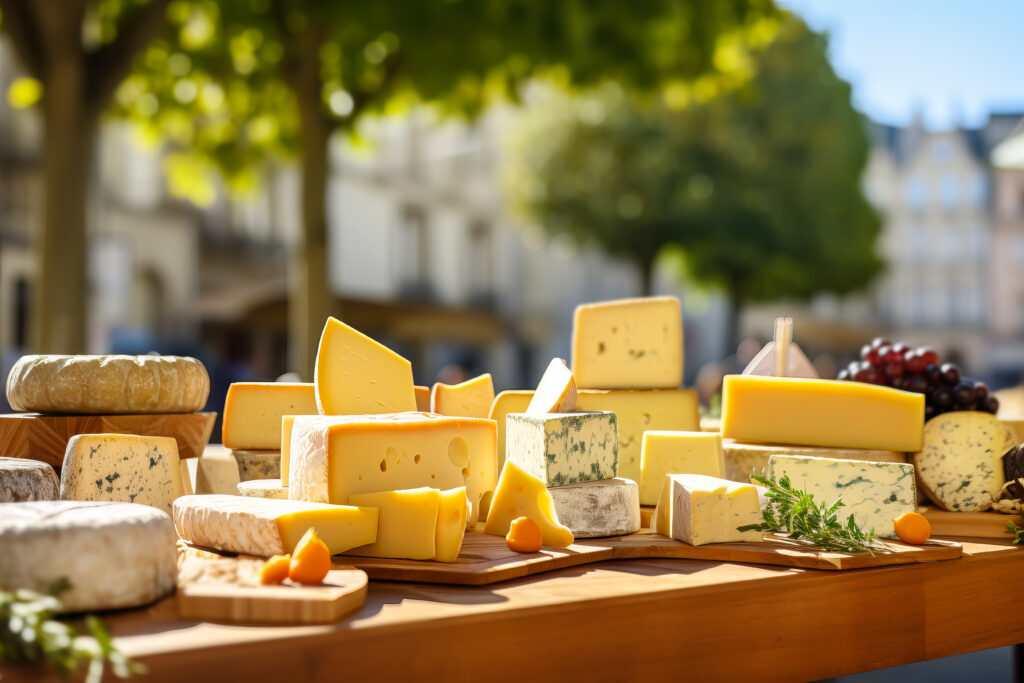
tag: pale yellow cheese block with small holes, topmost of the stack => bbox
[572,297,683,389]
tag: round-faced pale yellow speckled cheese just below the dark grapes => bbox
[910,412,1014,512]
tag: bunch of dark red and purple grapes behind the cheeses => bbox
[837,337,999,420]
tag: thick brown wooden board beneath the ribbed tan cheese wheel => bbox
[0,413,217,467]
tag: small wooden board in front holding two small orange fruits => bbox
[175,544,369,624]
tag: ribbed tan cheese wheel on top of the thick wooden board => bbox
[7,355,210,415]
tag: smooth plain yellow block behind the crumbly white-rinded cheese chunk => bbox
[640,430,725,505]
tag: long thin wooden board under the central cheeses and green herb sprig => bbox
[346,529,963,586]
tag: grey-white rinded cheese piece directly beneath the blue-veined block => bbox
[548,477,640,539]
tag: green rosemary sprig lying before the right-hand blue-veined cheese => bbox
[738,474,892,555]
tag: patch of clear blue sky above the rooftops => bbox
[778,0,1024,128]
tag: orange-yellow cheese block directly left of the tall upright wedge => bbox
[221,382,316,451]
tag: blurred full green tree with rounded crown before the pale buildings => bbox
[510,17,883,348]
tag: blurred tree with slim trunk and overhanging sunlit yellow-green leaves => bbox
[118,0,776,377]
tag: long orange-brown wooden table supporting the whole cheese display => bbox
[4,540,1024,683]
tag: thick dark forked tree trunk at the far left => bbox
[0,0,168,353]
